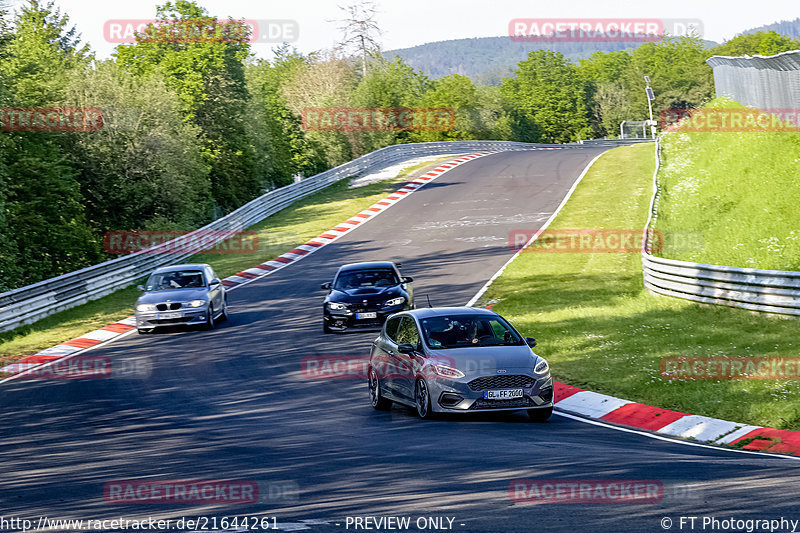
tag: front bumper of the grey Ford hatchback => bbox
[426,374,553,413]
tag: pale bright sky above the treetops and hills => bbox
[15,0,800,58]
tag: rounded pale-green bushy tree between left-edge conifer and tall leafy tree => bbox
[66,61,212,232]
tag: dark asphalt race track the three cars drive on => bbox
[0,147,800,532]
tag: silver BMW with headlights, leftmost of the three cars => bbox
[135,263,228,334]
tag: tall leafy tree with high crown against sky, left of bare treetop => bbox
[116,0,260,211]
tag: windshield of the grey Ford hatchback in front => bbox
[422,315,525,350]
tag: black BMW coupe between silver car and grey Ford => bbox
[322,261,414,333]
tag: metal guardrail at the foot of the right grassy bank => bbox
[642,141,800,316]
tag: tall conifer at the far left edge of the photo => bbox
[0,0,101,286]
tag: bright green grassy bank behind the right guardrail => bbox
[655,99,800,270]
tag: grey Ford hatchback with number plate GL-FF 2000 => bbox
[367,307,553,421]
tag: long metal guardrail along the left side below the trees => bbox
[0,141,580,332]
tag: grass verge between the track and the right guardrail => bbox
[483,144,800,429]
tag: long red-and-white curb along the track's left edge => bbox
[0,152,500,383]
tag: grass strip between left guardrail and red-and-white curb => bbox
[0,155,462,364]
